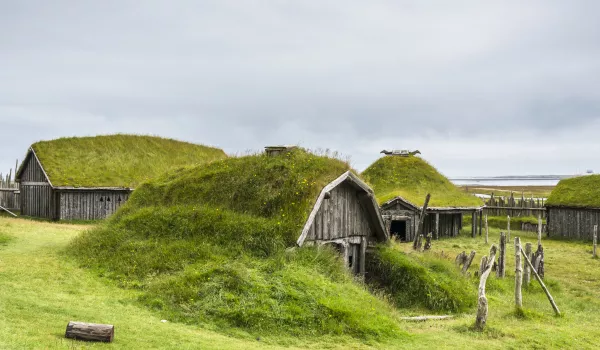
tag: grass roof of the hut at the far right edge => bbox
[546,175,600,208]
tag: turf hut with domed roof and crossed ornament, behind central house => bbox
[362,154,483,241]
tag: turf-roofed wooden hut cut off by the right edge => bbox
[546,175,600,240]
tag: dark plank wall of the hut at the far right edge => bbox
[547,207,600,240]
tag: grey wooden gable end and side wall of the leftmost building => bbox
[17,149,131,220]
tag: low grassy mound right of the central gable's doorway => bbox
[367,243,477,312]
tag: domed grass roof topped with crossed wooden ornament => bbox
[361,156,483,207]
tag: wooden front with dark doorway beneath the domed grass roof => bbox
[381,197,482,241]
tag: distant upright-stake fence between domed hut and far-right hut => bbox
[483,192,546,219]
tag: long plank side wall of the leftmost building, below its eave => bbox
[58,190,129,220]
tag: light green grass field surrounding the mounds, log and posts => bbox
[0,217,600,349]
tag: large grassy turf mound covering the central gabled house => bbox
[69,149,399,338]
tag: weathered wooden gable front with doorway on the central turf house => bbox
[297,172,388,275]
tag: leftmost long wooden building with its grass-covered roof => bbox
[17,135,226,220]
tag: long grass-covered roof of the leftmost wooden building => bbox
[32,134,226,188]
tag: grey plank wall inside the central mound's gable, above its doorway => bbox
[306,183,373,241]
